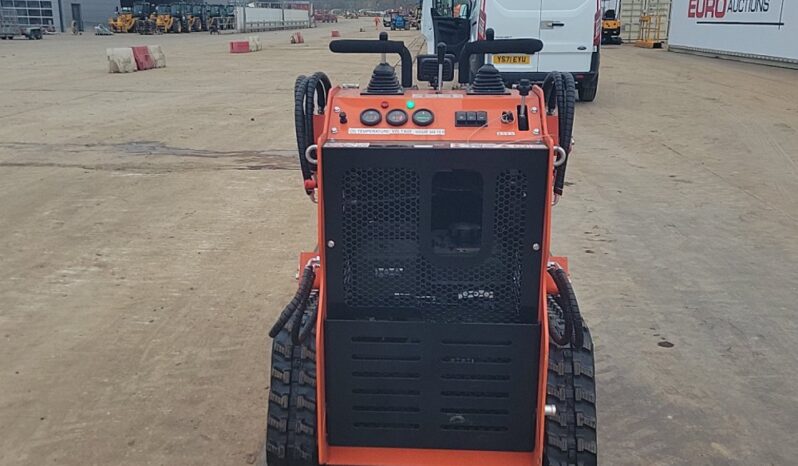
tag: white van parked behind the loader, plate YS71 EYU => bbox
[422,0,601,102]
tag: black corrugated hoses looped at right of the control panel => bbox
[543,71,576,195]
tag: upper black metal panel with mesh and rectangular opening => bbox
[322,147,549,323]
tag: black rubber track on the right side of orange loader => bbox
[544,296,598,466]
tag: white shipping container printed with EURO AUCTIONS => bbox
[668,0,798,67]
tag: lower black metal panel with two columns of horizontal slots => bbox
[325,319,540,451]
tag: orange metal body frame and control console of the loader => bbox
[300,86,568,466]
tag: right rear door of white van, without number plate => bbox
[538,0,601,72]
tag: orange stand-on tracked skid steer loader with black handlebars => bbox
[265,31,597,466]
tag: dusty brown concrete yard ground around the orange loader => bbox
[0,18,798,465]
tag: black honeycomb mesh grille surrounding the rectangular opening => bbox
[342,168,529,322]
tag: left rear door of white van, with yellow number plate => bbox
[484,0,548,73]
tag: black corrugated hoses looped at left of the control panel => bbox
[294,71,332,194]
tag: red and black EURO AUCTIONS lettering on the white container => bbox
[687,0,795,27]
